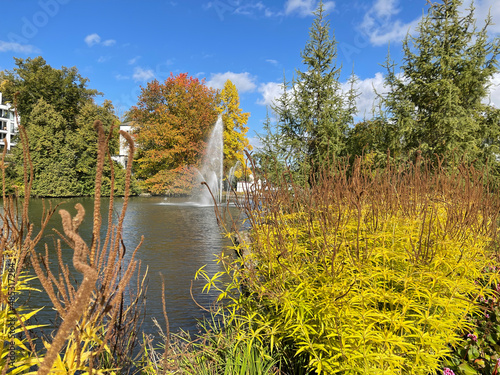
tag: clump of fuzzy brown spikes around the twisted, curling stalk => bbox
[30,121,145,375]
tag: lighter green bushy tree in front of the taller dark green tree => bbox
[12,98,124,197]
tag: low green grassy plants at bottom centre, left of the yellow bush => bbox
[137,312,279,375]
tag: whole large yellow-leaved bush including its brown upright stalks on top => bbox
[200,159,499,374]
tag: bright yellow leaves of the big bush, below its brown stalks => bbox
[250,204,497,374]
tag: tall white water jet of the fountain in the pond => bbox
[192,115,224,206]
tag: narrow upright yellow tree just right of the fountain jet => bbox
[217,80,252,177]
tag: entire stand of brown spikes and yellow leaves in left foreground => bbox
[0,104,146,374]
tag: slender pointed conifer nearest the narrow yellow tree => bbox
[273,1,356,176]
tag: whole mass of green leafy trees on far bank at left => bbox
[1,57,124,196]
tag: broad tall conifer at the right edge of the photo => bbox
[384,0,500,164]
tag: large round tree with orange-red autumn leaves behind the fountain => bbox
[130,73,217,194]
